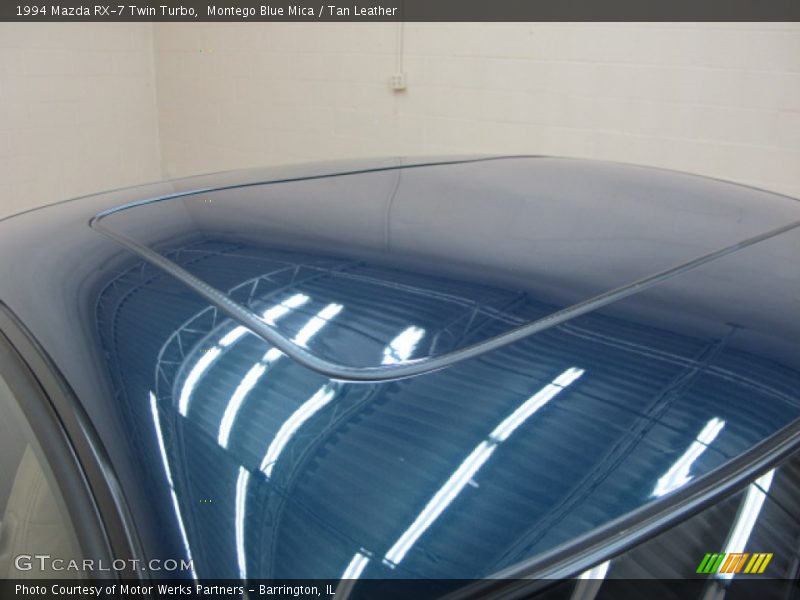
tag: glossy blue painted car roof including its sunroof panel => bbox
[0,158,800,578]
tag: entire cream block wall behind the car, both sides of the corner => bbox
[0,23,800,216]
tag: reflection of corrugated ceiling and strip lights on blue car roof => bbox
[97,239,800,580]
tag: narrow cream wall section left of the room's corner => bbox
[0,23,161,217]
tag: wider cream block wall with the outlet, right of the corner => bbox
[155,23,800,196]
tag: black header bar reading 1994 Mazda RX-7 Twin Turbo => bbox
[0,0,800,23]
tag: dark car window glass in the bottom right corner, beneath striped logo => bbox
[544,454,800,600]
